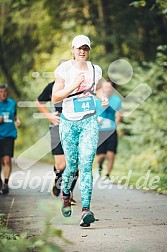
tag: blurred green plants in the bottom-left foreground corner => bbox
[0,201,70,252]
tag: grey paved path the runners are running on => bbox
[0,160,167,252]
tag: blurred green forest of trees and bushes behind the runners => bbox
[0,0,167,193]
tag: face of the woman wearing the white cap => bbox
[72,45,90,61]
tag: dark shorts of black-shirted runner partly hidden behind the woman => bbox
[50,125,64,155]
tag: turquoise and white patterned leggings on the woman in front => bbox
[59,115,99,208]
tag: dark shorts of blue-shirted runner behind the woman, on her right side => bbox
[96,130,118,155]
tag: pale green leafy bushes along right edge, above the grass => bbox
[120,46,167,172]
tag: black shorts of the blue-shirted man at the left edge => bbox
[0,137,15,158]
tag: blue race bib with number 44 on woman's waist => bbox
[73,96,95,113]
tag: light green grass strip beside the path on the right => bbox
[93,151,167,194]
